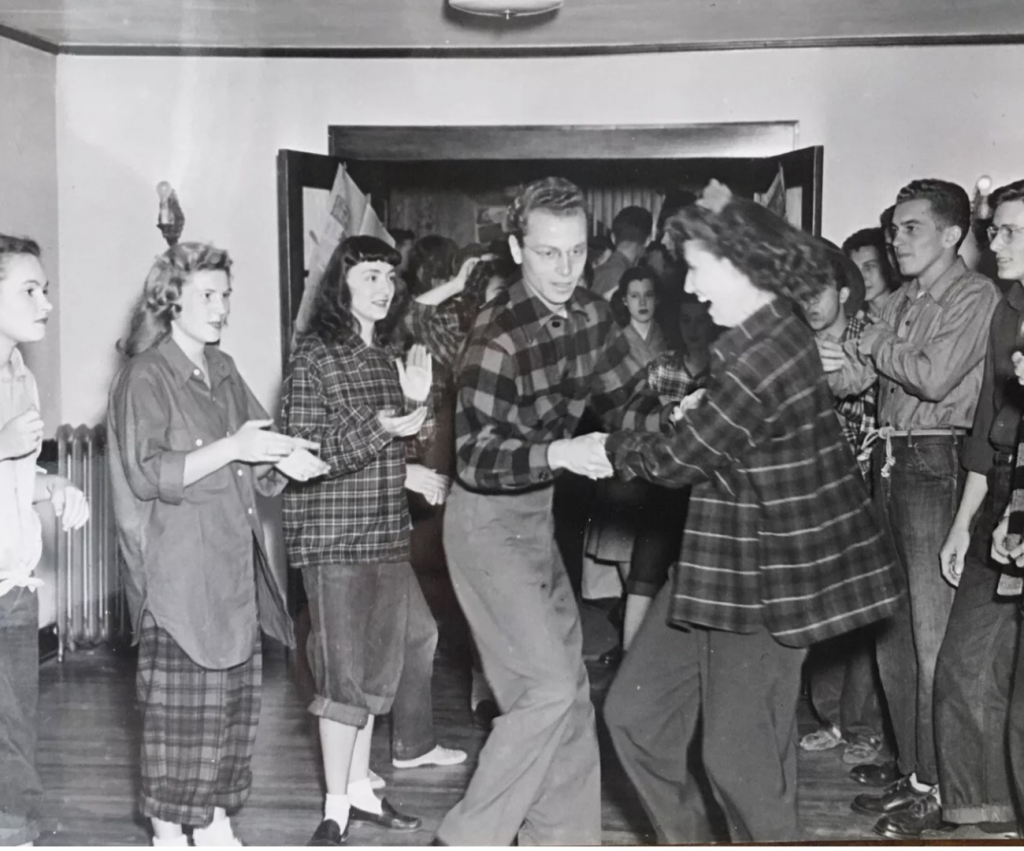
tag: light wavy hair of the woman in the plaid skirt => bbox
[118,243,231,357]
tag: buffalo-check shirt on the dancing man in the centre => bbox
[456,281,668,492]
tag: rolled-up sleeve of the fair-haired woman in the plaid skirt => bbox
[113,370,188,505]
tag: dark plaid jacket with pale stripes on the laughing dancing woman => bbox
[606,300,901,647]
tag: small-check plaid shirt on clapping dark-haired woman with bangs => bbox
[283,334,415,567]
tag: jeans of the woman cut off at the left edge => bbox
[0,588,43,845]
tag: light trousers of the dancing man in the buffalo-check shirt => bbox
[437,484,601,845]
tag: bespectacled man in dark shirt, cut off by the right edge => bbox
[925,180,1024,839]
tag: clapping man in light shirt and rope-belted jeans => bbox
[819,179,999,839]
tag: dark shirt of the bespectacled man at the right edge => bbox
[962,282,1024,475]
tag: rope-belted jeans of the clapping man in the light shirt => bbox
[873,434,962,783]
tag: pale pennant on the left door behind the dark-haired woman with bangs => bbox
[292,163,394,346]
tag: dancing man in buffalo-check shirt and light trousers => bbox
[435,177,669,845]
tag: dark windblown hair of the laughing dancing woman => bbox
[667,198,831,305]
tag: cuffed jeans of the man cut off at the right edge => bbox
[935,463,1018,824]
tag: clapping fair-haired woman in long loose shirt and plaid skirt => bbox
[108,243,325,845]
